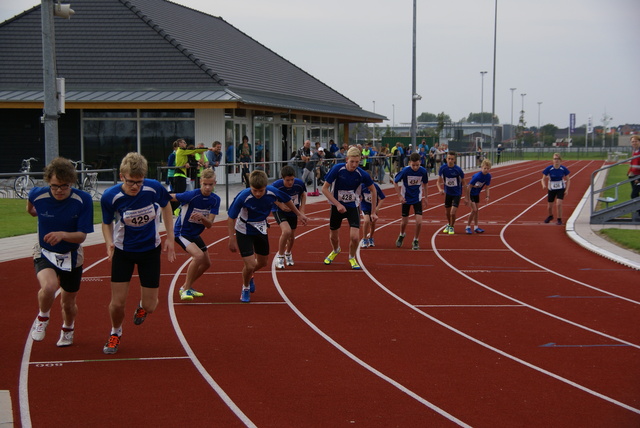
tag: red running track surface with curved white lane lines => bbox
[0,161,640,427]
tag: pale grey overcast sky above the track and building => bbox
[0,0,640,128]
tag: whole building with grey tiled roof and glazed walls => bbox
[0,0,386,182]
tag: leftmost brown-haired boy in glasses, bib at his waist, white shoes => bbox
[27,158,93,347]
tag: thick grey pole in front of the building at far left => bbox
[41,0,60,165]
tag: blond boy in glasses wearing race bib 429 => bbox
[100,152,176,354]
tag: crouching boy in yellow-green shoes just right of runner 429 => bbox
[171,168,220,301]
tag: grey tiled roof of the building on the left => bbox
[0,0,384,120]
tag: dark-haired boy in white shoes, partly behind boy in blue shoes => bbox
[272,165,307,269]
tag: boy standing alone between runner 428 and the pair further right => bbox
[393,152,429,250]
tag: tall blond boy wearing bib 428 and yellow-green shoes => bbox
[322,147,378,269]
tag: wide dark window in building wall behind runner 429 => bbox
[82,110,195,180]
